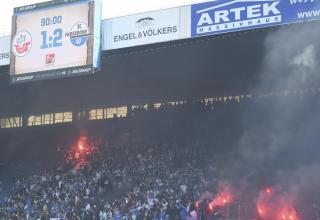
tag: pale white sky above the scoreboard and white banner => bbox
[0,0,209,33]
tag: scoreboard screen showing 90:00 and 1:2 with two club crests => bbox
[10,0,101,83]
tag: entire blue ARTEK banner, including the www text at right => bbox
[191,0,320,37]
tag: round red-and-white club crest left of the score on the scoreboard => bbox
[12,31,32,57]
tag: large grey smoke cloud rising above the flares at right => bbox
[215,23,320,211]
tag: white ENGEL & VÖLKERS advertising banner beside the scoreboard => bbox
[103,8,181,50]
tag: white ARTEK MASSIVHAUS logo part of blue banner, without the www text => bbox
[192,0,282,36]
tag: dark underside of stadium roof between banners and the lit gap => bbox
[0,23,320,115]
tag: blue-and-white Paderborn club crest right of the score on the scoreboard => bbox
[65,22,89,47]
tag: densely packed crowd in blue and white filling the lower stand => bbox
[0,126,220,220]
